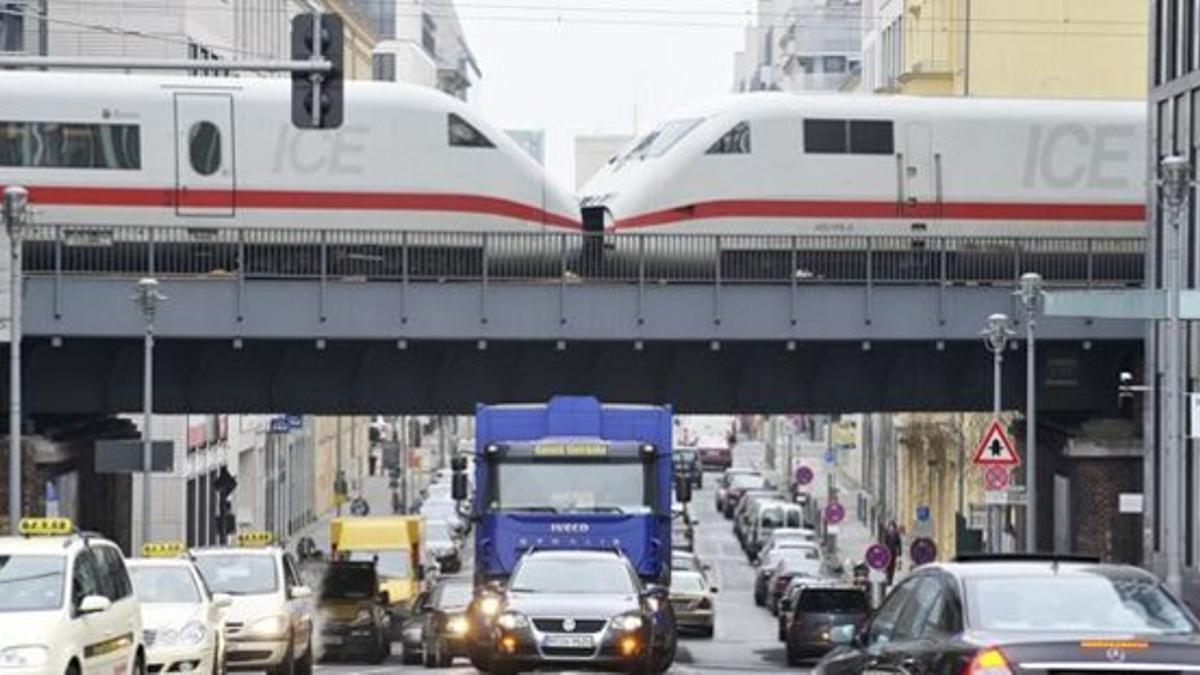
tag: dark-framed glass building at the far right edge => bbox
[1145,0,1200,607]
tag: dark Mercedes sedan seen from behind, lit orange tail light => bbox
[816,556,1200,675]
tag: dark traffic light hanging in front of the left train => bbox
[292,13,344,129]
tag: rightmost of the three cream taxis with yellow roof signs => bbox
[192,532,314,675]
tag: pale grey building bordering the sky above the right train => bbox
[733,0,863,91]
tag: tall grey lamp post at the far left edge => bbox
[4,186,29,534]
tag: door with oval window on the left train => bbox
[175,94,236,217]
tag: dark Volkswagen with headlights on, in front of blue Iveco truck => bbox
[488,551,677,675]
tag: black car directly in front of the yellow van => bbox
[317,562,391,663]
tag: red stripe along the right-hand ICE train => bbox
[616,199,1146,229]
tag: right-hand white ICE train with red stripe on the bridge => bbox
[581,92,1147,239]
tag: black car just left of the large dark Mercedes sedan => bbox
[779,583,871,665]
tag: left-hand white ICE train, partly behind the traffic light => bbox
[0,71,580,233]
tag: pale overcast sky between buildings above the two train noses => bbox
[455,0,754,186]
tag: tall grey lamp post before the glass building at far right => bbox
[1156,155,1193,593]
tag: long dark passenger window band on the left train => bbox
[0,121,142,169]
